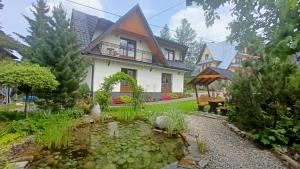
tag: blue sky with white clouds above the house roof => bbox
[0,0,233,42]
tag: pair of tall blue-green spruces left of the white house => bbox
[20,0,87,109]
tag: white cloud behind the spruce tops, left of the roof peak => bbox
[24,0,104,17]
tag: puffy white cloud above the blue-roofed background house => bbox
[169,6,233,41]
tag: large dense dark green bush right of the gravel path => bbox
[229,58,300,147]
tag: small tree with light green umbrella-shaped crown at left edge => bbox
[0,63,58,117]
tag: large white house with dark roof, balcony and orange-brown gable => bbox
[71,5,189,97]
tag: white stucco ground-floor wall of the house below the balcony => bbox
[86,59,184,92]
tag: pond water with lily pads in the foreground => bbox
[29,121,184,169]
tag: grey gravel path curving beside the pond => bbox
[186,116,287,169]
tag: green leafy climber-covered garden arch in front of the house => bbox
[96,72,143,110]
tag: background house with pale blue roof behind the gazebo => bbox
[192,41,251,76]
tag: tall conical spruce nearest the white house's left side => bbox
[46,4,87,107]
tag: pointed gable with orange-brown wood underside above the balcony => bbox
[85,5,165,64]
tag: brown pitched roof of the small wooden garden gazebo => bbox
[188,67,234,86]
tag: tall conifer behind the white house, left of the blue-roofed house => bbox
[175,18,199,69]
